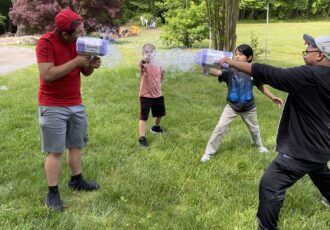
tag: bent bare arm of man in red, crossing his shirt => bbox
[38,55,90,82]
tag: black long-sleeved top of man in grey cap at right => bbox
[252,64,330,163]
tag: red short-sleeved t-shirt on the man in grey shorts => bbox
[36,32,82,106]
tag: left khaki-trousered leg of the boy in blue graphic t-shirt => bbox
[204,105,238,156]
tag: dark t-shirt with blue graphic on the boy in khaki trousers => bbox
[219,69,260,112]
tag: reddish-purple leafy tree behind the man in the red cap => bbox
[9,0,124,35]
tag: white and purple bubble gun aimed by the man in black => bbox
[195,49,233,73]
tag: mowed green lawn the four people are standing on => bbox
[0,22,330,230]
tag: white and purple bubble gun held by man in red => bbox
[76,37,108,56]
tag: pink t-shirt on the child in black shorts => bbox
[140,64,164,98]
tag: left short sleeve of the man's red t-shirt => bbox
[36,38,55,63]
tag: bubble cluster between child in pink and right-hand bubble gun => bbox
[151,49,195,72]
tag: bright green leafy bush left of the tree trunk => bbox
[161,2,209,47]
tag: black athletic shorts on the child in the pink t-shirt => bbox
[140,96,166,121]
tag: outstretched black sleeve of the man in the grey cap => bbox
[251,63,313,92]
